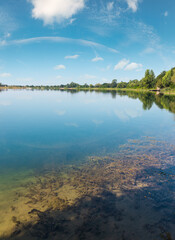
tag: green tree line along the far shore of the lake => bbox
[0,68,175,89]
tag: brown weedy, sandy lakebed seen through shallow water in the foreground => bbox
[0,138,175,240]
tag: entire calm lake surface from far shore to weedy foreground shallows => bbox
[0,90,175,240]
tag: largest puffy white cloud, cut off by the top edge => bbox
[29,0,85,24]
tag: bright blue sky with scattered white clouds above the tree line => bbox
[0,0,175,85]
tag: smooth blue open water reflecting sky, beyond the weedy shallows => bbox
[0,91,175,169]
